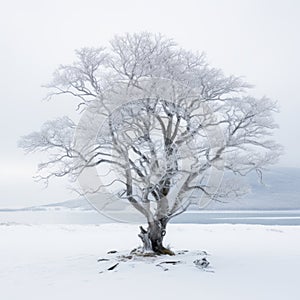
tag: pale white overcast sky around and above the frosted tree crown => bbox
[0,0,300,207]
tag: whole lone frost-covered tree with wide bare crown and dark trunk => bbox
[20,32,281,254]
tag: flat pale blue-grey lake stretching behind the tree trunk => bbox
[0,209,300,225]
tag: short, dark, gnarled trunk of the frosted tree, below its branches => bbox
[139,219,174,255]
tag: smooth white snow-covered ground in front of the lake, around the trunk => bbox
[0,223,300,300]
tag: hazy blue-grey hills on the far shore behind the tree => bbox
[1,168,300,211]
